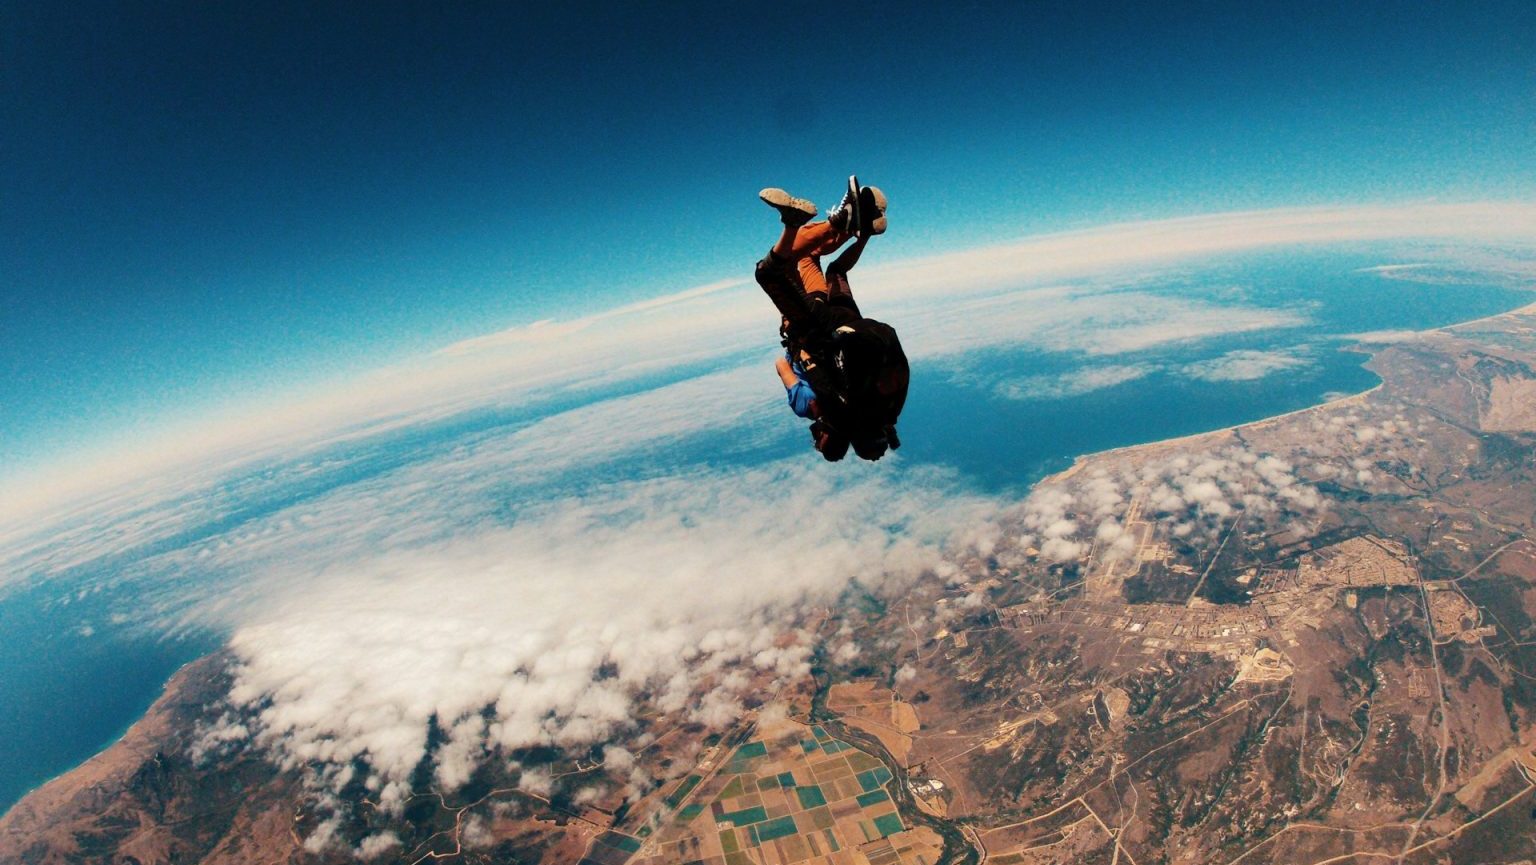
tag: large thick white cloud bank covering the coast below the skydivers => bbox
[203,464,997,808]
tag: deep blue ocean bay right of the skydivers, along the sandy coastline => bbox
[902,252,1536,493]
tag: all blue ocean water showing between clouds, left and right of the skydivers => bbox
[0,252,1533,810]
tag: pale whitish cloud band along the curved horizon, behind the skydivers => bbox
[0,201,1536,539]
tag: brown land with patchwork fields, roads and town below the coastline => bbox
[9,307,1536,865]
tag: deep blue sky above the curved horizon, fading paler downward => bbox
[0,0,1536,478]
